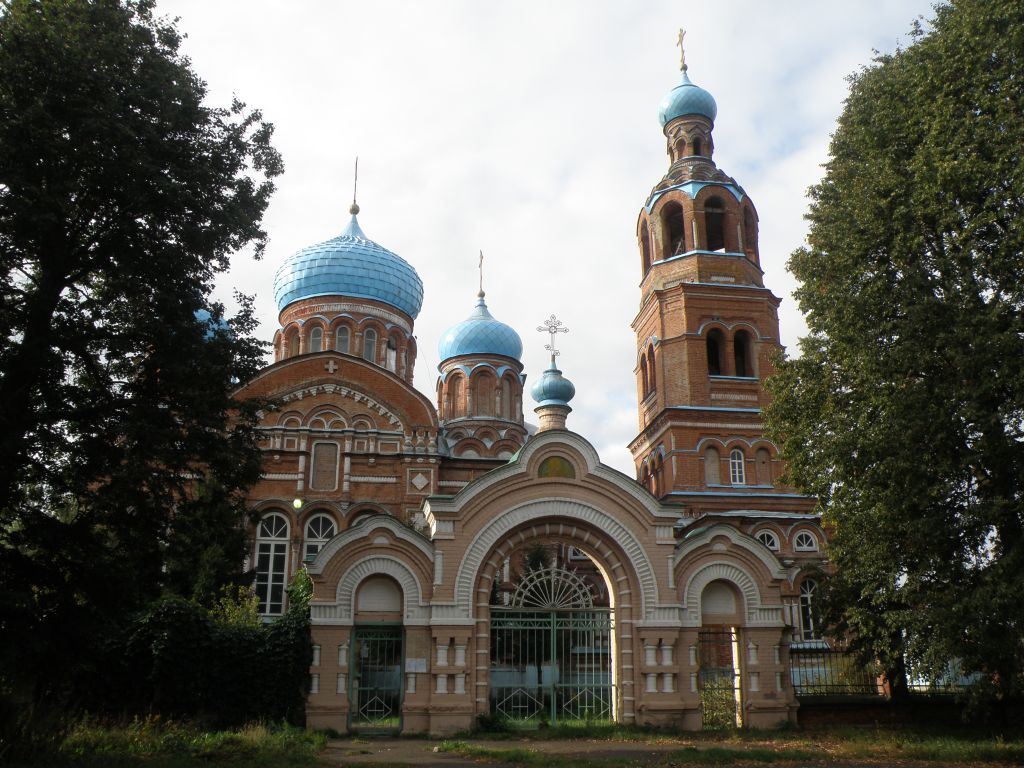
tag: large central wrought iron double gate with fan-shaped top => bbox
[490,567,614,725]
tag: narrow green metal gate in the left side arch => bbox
[348,627,403,731]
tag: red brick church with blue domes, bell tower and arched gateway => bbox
[237,51,825,734]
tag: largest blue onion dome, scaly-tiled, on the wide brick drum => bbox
[273,214,423,319]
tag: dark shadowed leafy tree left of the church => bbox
[0,0,282,741]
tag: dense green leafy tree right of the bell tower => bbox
[766,0,1024,712]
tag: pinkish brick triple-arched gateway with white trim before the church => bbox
[307,429,793,733]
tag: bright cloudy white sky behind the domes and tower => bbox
[157,0,931,475]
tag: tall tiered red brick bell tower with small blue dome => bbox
[630,48,803,514]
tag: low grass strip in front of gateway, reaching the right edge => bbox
[438,726,1024,768]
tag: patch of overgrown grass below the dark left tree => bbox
[11,718,327,768]
